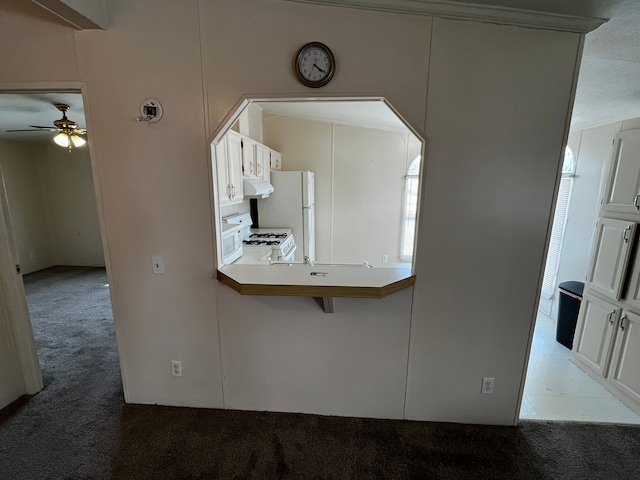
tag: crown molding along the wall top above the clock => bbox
[285,0,607,34]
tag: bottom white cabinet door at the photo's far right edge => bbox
[609,311,640,403]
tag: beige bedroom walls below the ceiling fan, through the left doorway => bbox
[0,143,104,274]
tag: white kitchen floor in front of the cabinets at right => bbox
[520,313,640,424]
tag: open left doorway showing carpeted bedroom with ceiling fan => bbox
[0,91,117,402]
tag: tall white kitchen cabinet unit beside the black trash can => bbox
[573,126,640,412]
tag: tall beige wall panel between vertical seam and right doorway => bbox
[405,20,580,423]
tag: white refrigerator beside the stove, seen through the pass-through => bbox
[258,170,316,262]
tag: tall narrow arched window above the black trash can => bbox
[542,146,576,298]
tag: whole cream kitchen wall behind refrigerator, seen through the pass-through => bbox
[263,116,420,263]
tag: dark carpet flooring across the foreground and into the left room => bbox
[0,267,640,480]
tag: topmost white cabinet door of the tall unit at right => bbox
[602,130,640,213]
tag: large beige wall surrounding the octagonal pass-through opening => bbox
[0,0,580,424]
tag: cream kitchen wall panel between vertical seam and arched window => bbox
[332,125,409,264]
